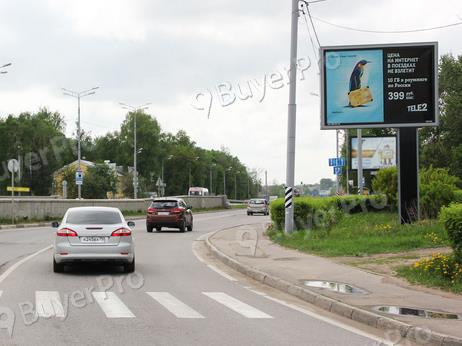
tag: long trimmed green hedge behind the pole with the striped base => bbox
[270,195,386,229]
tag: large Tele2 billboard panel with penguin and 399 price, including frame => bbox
[321,42,438,129]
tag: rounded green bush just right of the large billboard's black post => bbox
[420,166,459,219]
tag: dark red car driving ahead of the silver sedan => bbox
[146,198,193,232]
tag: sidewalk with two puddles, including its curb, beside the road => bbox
[206,225,462,345]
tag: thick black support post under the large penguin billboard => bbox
[397,127,420,224]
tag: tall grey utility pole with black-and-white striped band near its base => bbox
[284,0,299,233]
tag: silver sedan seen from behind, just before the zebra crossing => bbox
[52,207,135,273]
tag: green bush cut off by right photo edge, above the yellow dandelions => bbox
[440,203,462,264]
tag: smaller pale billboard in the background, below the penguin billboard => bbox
[350,137,396,170]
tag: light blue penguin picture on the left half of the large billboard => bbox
[325,49,384,125]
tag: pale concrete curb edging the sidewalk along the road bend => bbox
[204,230,462,346]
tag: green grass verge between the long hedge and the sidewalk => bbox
[268,212,448,257]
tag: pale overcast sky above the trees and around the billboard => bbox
[0,0,462,183]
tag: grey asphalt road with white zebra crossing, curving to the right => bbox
[0,210,390,345]
